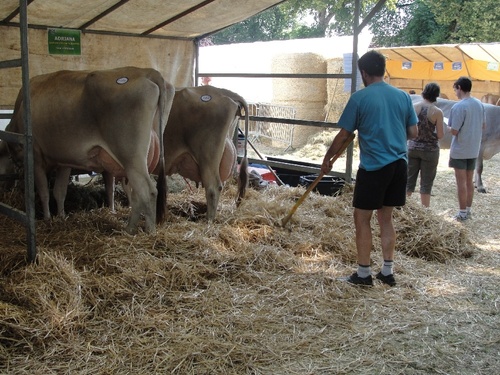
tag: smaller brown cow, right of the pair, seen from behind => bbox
[110,85,249,221]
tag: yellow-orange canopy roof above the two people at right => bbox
[376,43,500,82]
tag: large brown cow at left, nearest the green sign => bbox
[6,66,175,234]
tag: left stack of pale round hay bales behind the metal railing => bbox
[272,53,327,148]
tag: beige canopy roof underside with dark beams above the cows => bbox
[0,0,283,39]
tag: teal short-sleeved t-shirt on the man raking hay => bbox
[338,82,418,171]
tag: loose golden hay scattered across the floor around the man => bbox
[0,170,500,374]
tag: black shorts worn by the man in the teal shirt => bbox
[352,159,408,210]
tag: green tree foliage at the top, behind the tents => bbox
[210,0,500,47]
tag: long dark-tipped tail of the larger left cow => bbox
[155,75,175,224]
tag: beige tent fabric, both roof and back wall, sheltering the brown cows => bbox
[0,0,288,109]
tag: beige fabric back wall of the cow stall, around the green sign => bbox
[0,26,199,109]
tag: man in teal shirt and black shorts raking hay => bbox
[321,51,418,286]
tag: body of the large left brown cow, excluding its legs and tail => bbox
[8,67,164,171]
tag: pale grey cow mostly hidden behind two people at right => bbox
[411,95,500,193]
